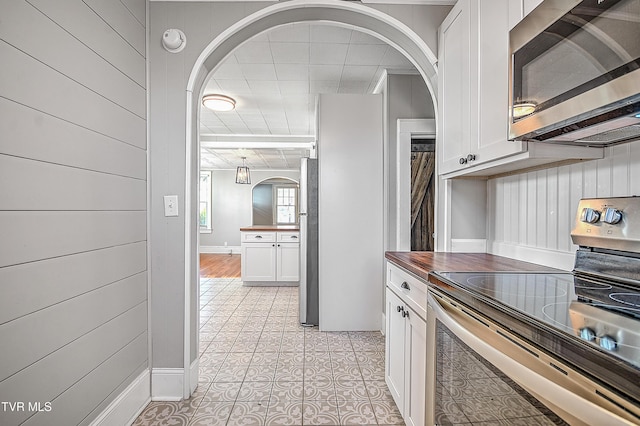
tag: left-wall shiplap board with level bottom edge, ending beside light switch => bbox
[0,154,147,211]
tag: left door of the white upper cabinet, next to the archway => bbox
[438,0,476,174]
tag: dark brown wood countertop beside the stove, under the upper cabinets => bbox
[385,251,566,281]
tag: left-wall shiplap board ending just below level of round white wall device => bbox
[27,0,146,87]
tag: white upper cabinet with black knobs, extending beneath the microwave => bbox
[437,0,603,178]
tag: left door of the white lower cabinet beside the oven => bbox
[385,288,406,416]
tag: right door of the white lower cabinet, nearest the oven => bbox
[404,310,427,426]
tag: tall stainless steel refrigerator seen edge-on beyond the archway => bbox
[299,158,319,326]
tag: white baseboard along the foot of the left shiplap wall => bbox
[90,369,151,426]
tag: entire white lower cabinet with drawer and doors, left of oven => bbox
[385,263,427,426]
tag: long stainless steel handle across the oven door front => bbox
[427,290,634,425]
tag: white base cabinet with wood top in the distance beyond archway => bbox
[241,231,300,285]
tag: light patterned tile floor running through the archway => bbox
[134,278,404,426]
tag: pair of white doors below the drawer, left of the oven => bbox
[385,284,427,426]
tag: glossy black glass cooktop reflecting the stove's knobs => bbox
[436,272,640,369]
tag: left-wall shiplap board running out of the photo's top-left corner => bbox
[0,1,146,118]
